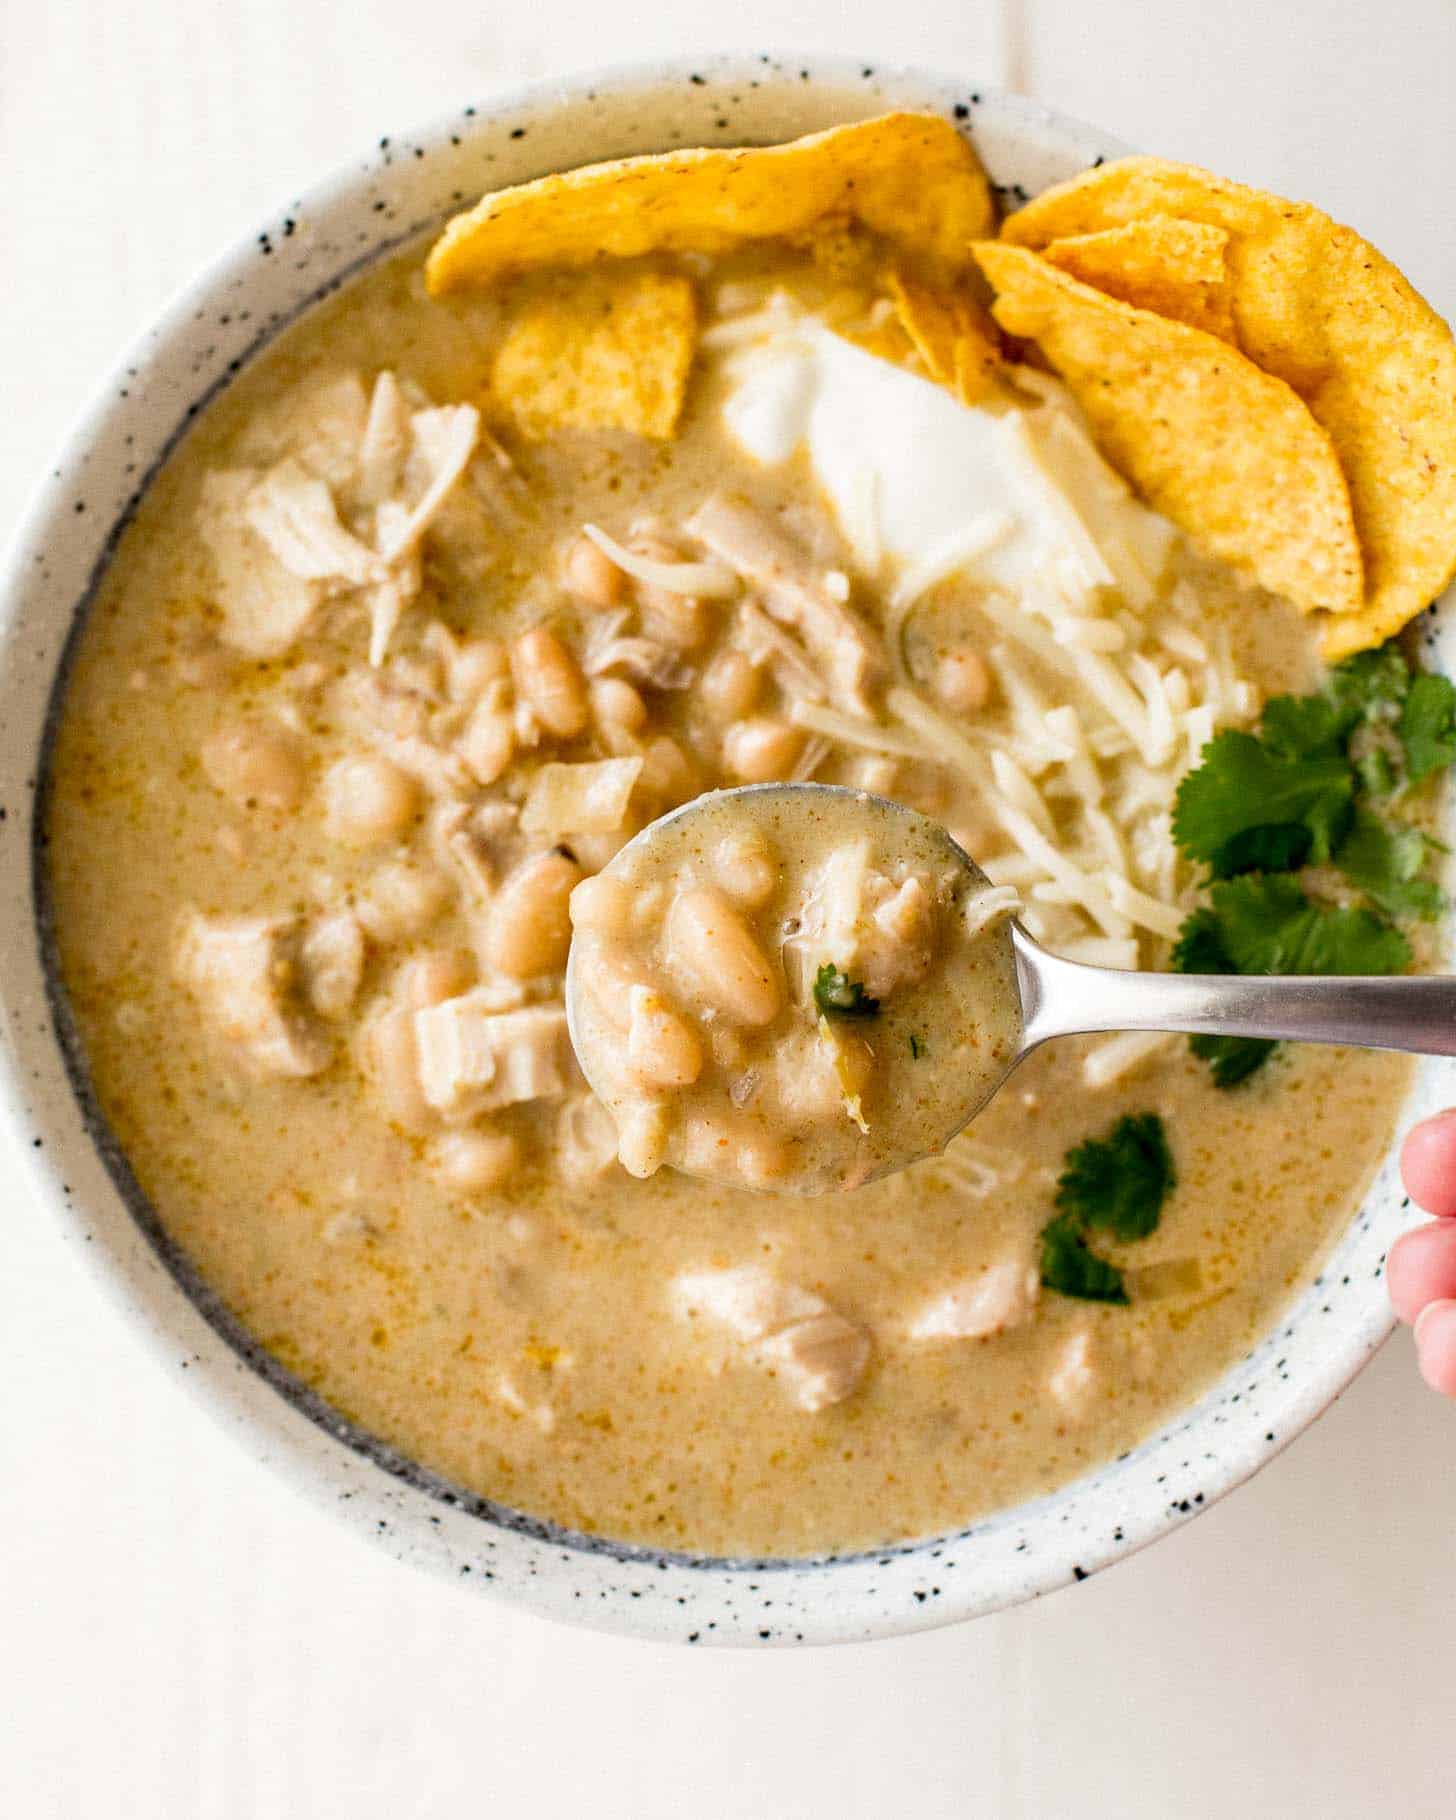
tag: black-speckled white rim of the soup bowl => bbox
[0,53,1452,1643]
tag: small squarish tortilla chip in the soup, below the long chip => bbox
[491,271,697,440]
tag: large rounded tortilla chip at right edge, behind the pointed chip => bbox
[1001,158,1456,657]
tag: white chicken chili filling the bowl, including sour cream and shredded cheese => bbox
[46,229,1409,1554]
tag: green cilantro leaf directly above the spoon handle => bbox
[1210,875,1411,974]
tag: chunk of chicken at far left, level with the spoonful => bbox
[177,914,331,1079]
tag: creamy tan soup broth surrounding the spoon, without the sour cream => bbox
[47,234,1409,1554]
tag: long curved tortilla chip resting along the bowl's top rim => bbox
[426,113,996,295]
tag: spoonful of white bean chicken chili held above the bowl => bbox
[568,784,1021,1194]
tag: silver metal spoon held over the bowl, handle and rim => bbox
[566,784,1456,1194]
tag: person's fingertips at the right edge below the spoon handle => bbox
[1385,1107,1456,1396]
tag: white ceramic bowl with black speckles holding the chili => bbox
[0,56,1456,1643]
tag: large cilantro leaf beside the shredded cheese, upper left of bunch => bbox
[1172,728,1354,877]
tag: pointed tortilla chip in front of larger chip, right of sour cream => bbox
[976,240,1363,612]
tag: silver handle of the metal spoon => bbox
[1012,928,1456,1056]
